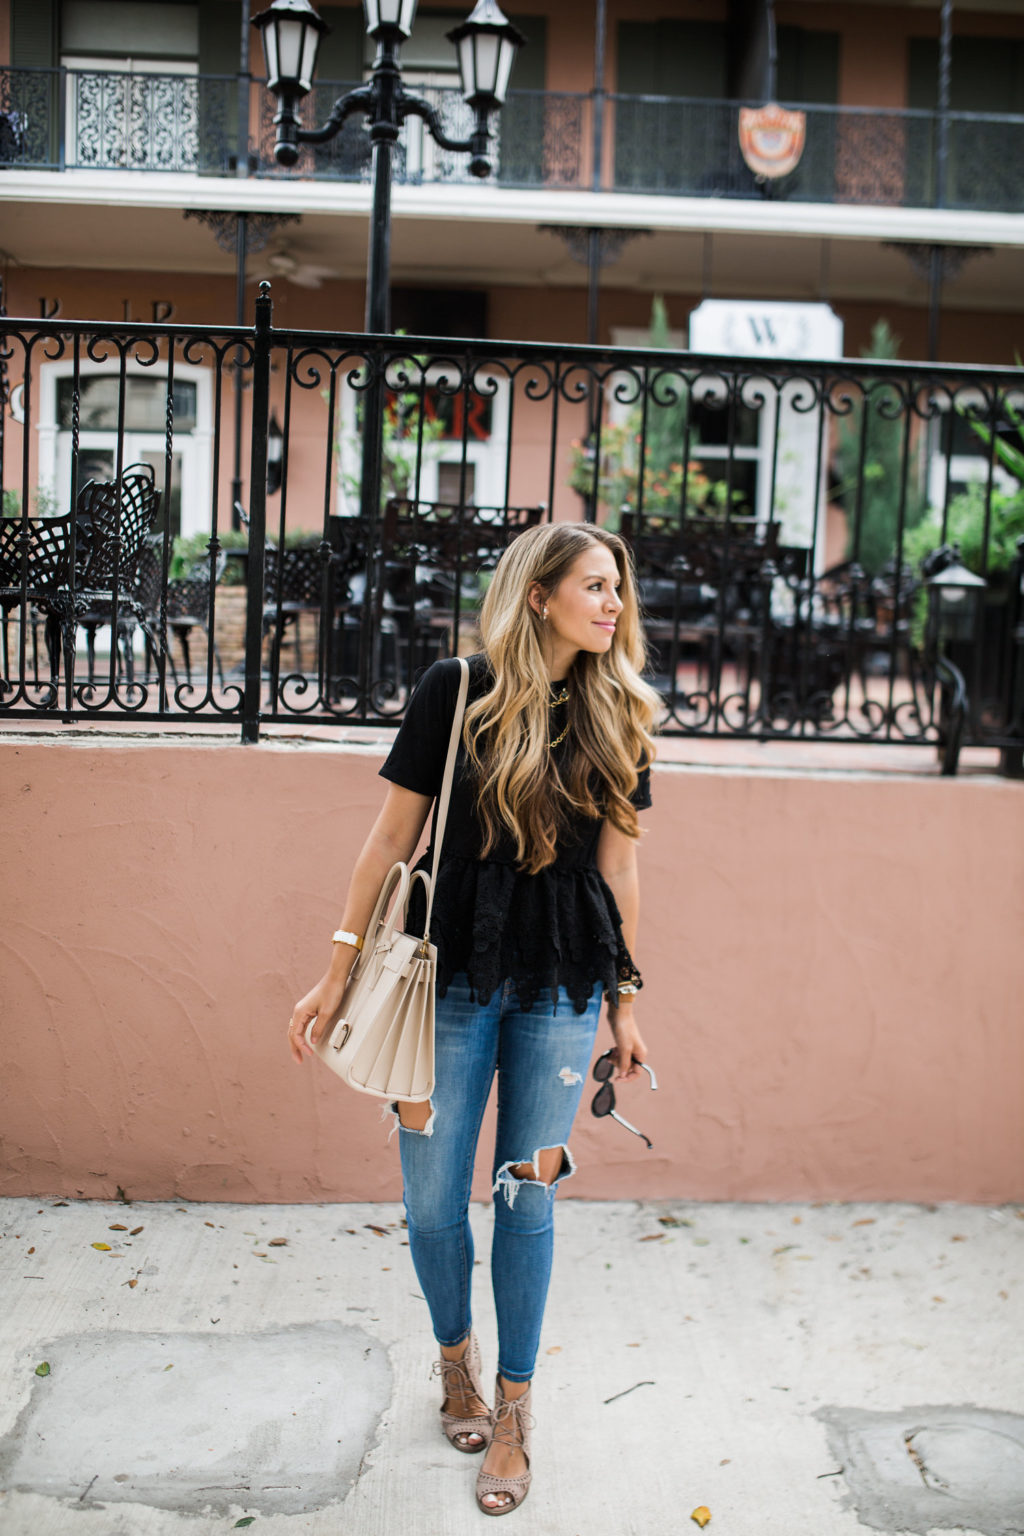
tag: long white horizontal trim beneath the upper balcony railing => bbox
[0,169,1024,247]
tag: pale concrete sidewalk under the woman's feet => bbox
[0,1198,1024,1536]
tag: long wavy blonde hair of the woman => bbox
[465,522,662,874]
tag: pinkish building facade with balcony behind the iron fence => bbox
[0,0,1024,543]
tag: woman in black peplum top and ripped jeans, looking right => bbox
[289,524,659,1514]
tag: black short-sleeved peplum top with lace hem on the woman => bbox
[381,654,651,1014]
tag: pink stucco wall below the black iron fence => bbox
[0,736,1024,1201]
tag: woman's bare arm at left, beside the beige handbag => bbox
[289,783,431,1063]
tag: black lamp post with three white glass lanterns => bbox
[252,0,525,333]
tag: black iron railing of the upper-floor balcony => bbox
[0,68,1024,212]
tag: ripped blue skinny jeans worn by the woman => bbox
[399,974,600,1381]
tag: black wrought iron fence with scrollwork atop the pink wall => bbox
[0,292,1024,768]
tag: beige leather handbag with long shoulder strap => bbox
[307,659,470,1103]
